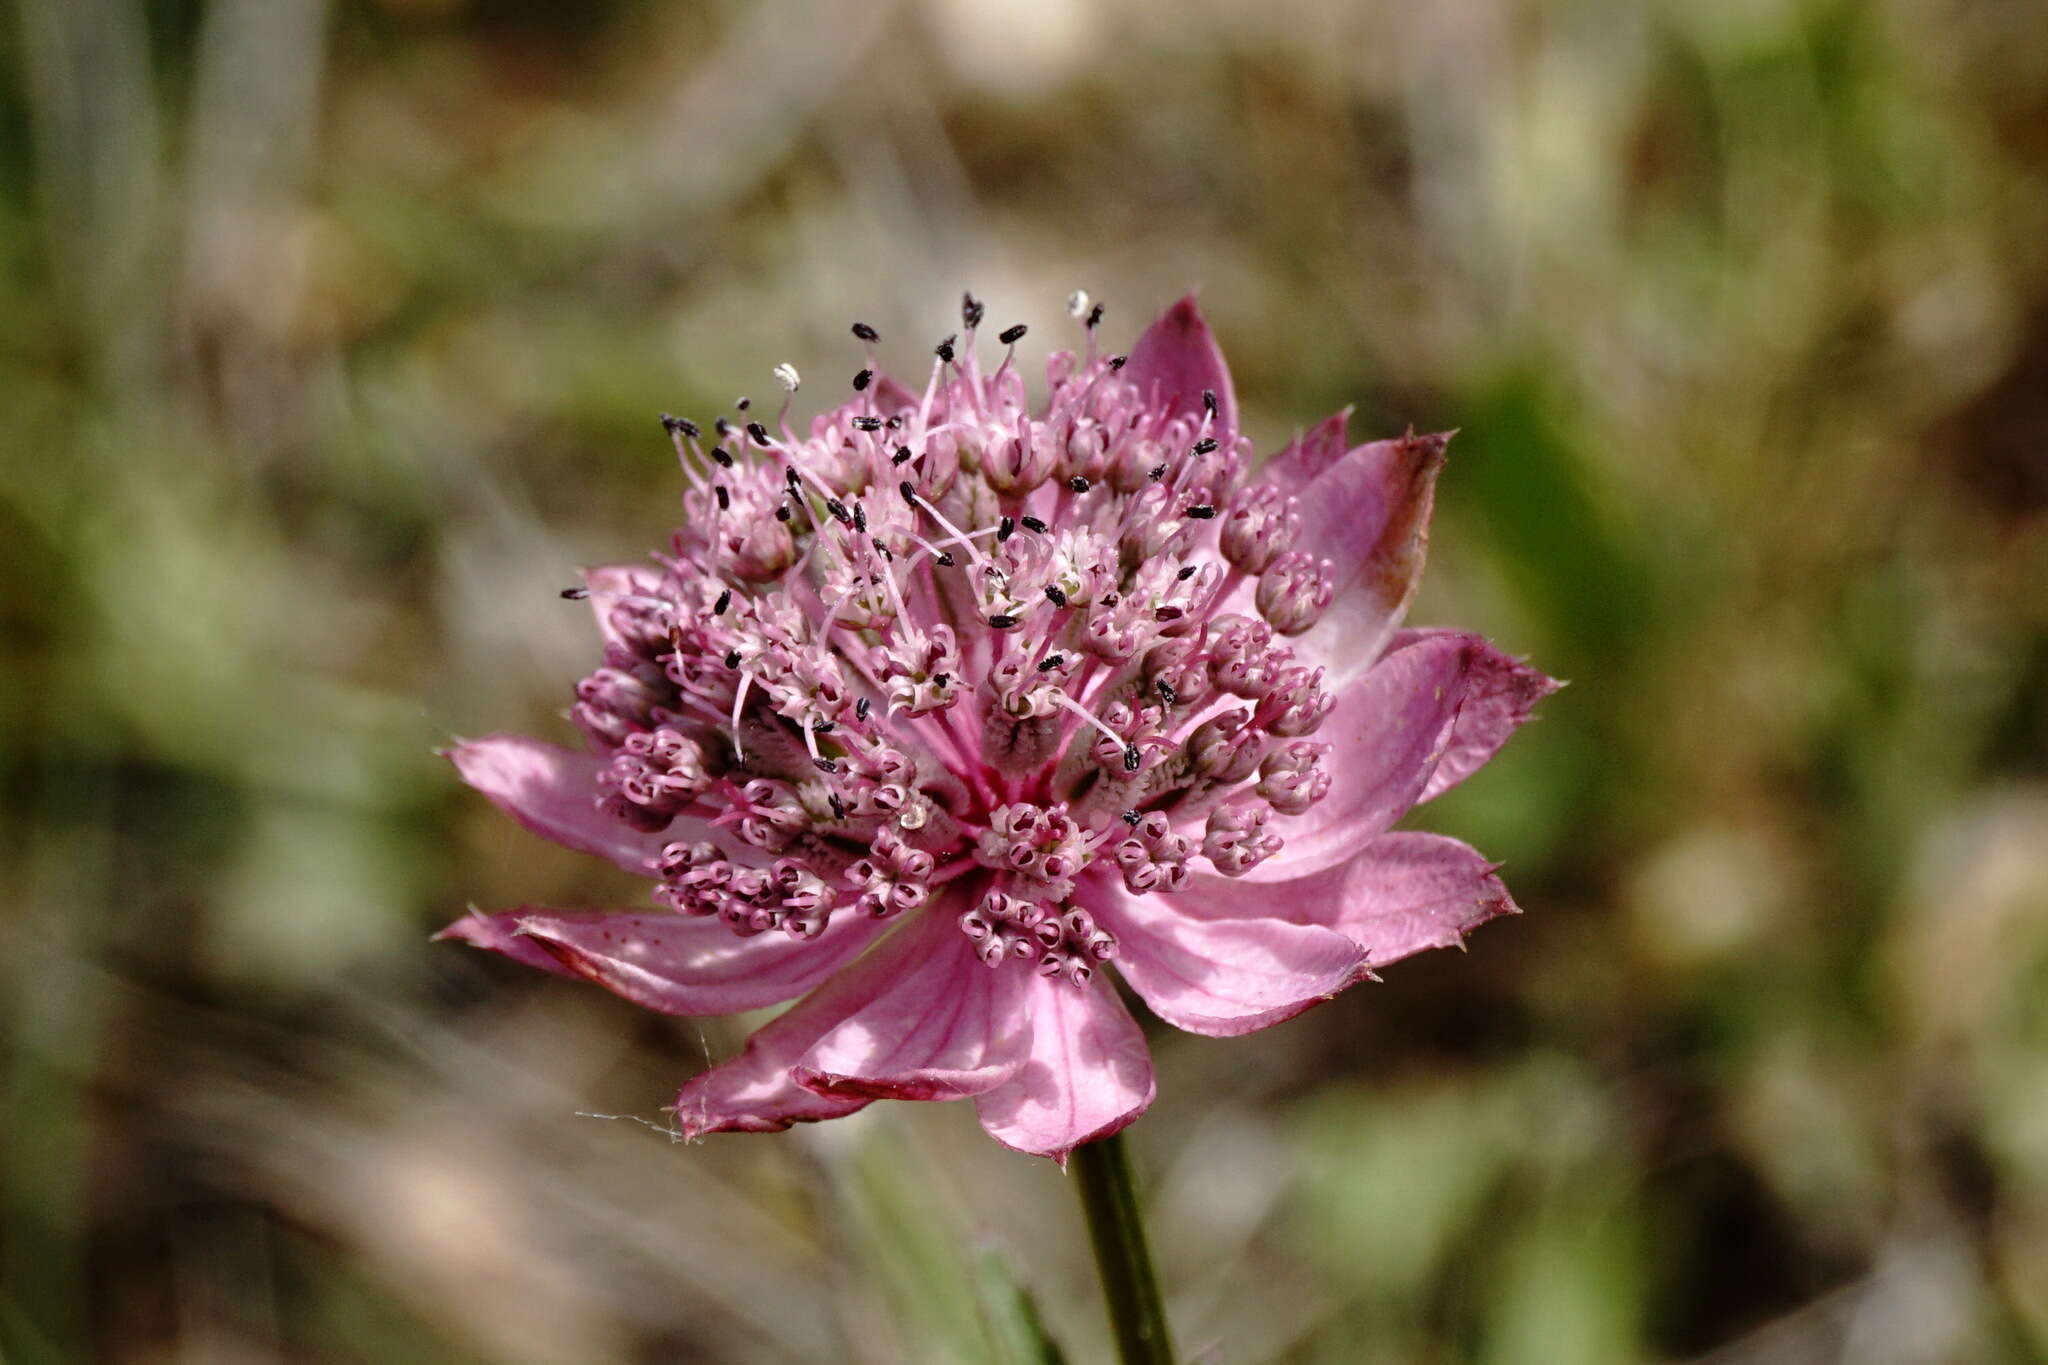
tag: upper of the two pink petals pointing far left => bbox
[444,735,713,876]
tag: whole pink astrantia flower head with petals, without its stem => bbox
[446,299,1554,1158]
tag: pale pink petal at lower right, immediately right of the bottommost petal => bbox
[1098,882,1366,1038]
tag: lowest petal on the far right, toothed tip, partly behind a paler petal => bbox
[1171,831,1520,968]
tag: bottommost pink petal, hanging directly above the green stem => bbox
[975,966,1153,1164]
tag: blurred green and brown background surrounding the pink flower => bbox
[0,0,2048,1365]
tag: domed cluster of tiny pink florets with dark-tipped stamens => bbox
[571,303,1331,980]
